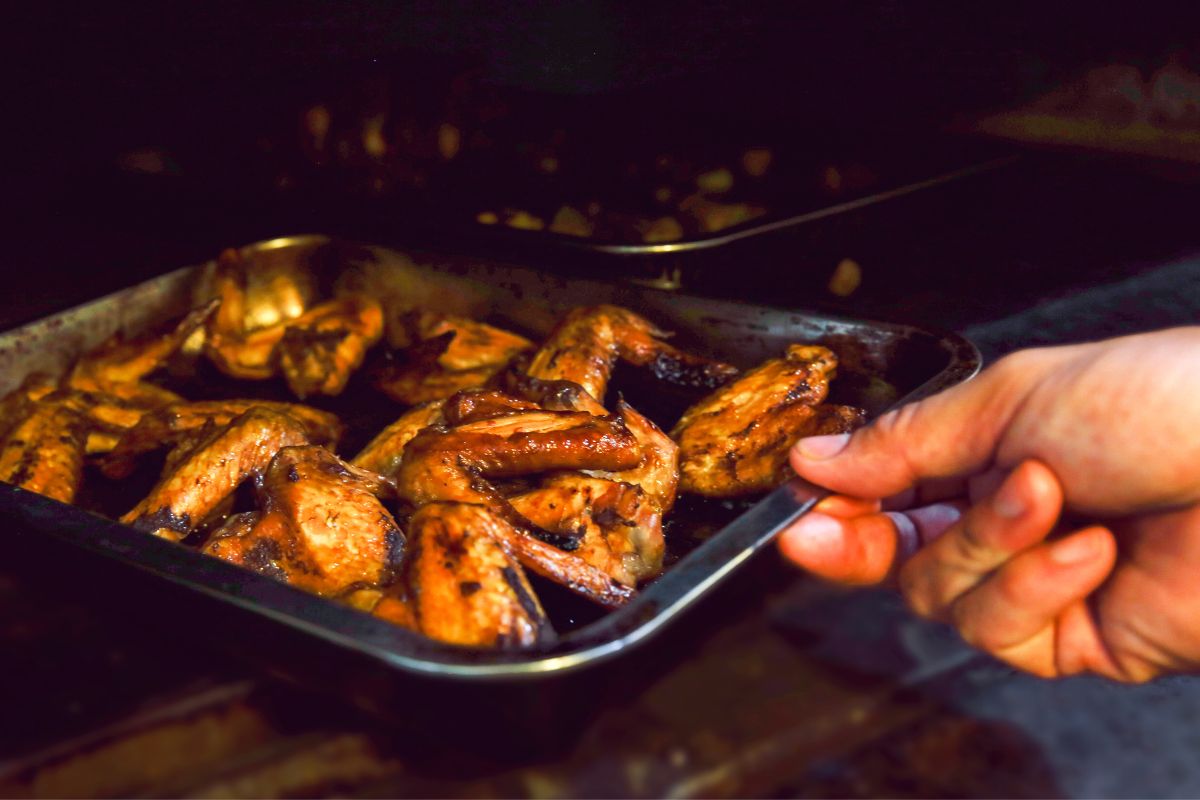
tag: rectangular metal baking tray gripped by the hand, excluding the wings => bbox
[0,236,979,738]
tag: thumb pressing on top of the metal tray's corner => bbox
[791,351,1044,498]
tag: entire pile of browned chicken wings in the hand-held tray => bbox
[0,251,864,648]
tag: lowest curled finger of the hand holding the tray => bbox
[952,527,1120,678]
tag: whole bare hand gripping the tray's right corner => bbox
[779,327,1200,682]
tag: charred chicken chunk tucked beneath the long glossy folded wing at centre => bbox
[509,473,666,588]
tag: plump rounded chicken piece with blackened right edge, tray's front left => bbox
[204,445,404,596]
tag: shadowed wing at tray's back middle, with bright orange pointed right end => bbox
[377,312,533,404]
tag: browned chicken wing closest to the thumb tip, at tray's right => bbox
[671,344,865,498]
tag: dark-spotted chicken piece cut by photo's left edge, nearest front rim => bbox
[0,391,88,503]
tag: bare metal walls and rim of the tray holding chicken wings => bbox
[0,236,979,684]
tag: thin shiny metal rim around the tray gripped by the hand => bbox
[0,234,982,681]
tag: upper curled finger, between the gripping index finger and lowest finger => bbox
[899,461,1062,620]
